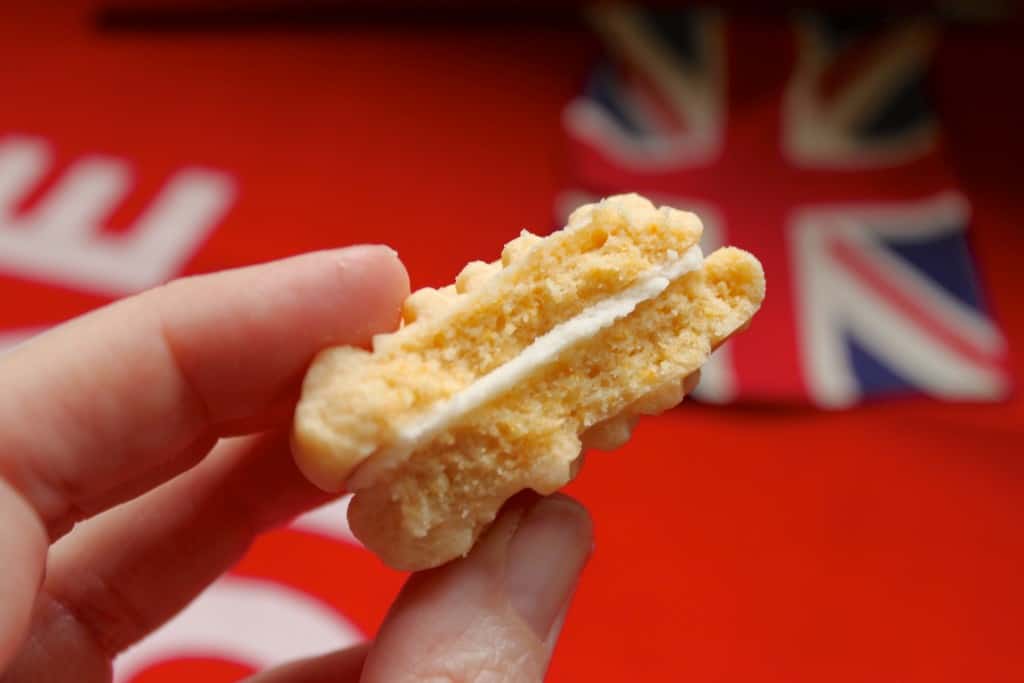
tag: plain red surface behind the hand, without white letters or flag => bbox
[0,3,1024,681]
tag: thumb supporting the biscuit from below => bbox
[361,494,593,683]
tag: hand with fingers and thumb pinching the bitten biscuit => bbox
[0,247,592,683]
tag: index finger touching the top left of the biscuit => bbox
[0,242,409,537]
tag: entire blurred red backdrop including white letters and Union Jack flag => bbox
[0,0,1024,683]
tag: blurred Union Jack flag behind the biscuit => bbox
[563,6,1009,407]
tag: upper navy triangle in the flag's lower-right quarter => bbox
[881,229,986,312]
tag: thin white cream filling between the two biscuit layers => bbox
[348,246,703,490]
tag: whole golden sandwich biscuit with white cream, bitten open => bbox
[293,195,765,570]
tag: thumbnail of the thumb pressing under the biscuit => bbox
[505,495,593,641]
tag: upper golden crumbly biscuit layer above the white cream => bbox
[295,195,702,490]
